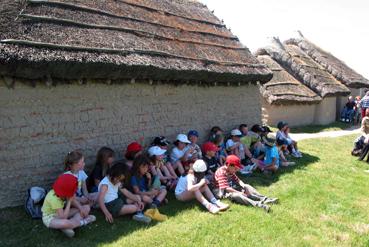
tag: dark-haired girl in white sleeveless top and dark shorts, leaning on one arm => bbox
[98,161,151,223]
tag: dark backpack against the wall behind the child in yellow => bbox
[24,187,46,219]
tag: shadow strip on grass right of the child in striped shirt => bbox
[240,153,320,186]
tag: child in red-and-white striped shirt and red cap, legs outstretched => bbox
[213,155,278,212]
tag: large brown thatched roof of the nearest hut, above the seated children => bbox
[0,0,272,83]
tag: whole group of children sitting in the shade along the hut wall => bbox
[42,122,301,237]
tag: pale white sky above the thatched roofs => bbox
[200,0,369,79]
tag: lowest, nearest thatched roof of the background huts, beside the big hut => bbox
[257,52,322,105]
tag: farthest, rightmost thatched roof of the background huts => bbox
[286,37,369,88]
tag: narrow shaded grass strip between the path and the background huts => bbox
[271,121,352,133]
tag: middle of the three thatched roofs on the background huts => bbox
[256,38,350,97]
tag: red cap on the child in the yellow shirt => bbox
[53,174,78,198]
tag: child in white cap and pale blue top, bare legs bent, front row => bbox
[175,160,229,214]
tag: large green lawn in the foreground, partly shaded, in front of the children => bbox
[0,136,369,246]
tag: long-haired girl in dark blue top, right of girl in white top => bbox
[131,154,167,208]
